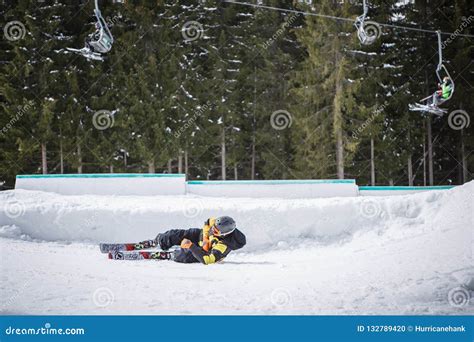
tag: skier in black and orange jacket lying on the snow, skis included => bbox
[100,216,246,265]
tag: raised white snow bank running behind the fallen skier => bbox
[0,182,474,251]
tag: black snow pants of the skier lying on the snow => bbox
[157,228,201,264]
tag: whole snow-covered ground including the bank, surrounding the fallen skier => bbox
[0,182,474,314]
